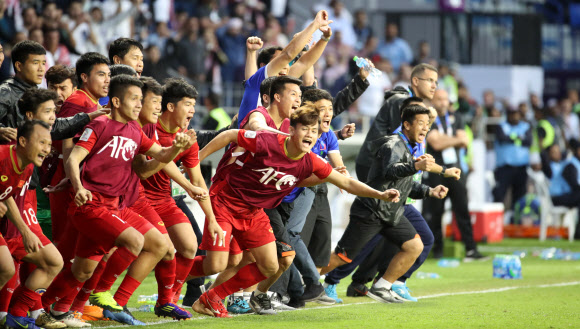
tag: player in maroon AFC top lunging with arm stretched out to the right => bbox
[193,105,399,317]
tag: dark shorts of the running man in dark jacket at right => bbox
[335,202,419,263]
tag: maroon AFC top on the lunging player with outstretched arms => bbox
[227,129,332,209]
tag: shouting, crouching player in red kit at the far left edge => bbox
[0,120,63,328]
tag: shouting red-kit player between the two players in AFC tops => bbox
[143,79,223,313]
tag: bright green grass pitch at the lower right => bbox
[88,239,580,329]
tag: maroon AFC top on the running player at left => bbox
[76,116,153,197]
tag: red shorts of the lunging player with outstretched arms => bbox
[199,184,276,253]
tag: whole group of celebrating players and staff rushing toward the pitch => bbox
[0,10,461,328]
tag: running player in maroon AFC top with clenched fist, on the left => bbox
[42,75,195,319]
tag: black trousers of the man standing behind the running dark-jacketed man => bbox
[423,174,476,253]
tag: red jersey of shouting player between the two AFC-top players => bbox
[142,122,199,203]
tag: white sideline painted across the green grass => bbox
[94,281,580,328]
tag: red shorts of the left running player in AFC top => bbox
[69,192,134,260]
